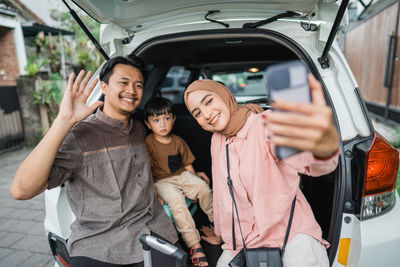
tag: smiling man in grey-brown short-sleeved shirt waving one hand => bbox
[10,57,177,267]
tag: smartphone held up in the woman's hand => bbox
[266,60,311,159]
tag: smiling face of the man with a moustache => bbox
[101,64,143,120]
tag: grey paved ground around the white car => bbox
[0,120,392,267]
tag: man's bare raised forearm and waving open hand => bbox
[10,71,102,199]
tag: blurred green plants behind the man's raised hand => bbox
[25,10,104,134]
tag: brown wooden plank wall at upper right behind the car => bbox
[345,3,400,108]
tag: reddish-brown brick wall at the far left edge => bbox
[0,27,19,87]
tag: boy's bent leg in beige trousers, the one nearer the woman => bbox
[180,171,214,222]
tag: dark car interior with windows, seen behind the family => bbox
[131,30,339,266]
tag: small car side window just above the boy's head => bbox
[161,66,190,104]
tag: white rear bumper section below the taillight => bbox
[332,194,400,267]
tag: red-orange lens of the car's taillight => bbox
[363,132,399,196]
